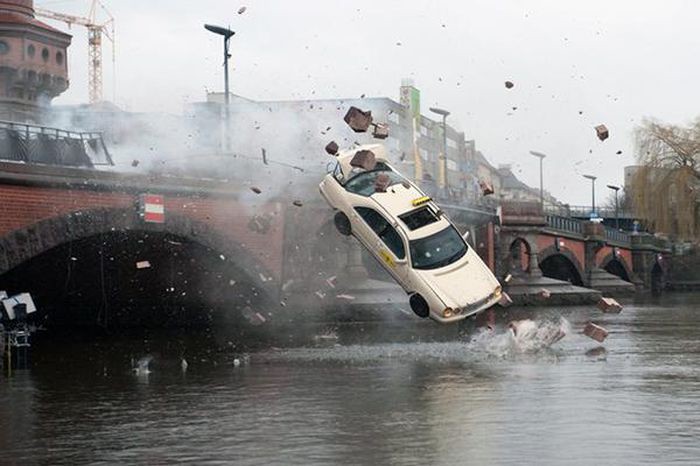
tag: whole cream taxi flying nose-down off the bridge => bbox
[319,144,501,323]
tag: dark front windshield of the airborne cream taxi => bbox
[409,225,467,270]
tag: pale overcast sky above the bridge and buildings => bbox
[36,0,700,204]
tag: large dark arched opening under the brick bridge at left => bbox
[0,231,269,342]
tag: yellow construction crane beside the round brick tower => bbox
[35,0,116,104]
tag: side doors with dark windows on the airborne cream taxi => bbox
[354,207,411,290]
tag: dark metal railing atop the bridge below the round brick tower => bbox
[0,120,114,167]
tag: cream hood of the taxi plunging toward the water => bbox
[416,248,499,308]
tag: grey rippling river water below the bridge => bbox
[0,294,700,466]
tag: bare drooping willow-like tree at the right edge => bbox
[628,119,700,239]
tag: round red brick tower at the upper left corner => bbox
[0,0,71,122]
